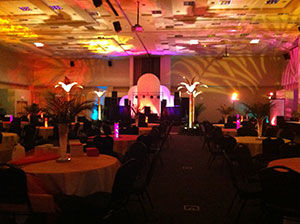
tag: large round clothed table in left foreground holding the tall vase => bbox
[22,155,120,197]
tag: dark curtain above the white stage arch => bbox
[133,57,160,85]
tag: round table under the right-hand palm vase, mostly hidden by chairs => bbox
[234,136,290,156]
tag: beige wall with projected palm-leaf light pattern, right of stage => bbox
[171,56,286,122]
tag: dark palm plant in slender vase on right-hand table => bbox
[244,102,272,138]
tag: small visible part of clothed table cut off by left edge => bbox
[0,132,19,163]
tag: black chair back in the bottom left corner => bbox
[0,163,32,211]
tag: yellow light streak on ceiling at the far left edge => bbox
[0,18,38,38]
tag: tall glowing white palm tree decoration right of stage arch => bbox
[177,77,208,128]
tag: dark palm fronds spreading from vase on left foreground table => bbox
[44,92,94,123]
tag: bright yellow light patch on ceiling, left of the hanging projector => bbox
[83,35,133,54]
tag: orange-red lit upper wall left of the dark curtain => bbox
[33,57,129,88]
